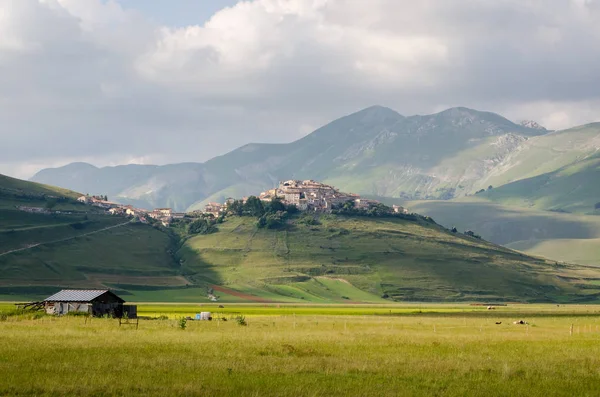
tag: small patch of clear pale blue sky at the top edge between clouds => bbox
[117,0,240,26]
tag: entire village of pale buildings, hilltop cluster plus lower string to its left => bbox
[39,180,408,227]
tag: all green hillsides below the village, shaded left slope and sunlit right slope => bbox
[0,172,600,303]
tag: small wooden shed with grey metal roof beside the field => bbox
[44,289,137,318]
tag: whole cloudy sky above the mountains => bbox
[0,0,600,178]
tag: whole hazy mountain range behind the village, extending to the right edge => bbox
[31,106,600,212]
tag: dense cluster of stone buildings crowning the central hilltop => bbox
[203,180,408,217]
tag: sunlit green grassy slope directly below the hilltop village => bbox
[179,215,598,302]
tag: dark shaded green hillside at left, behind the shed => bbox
[0,175,186,300]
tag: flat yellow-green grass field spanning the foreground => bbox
[0,304,600,396]
